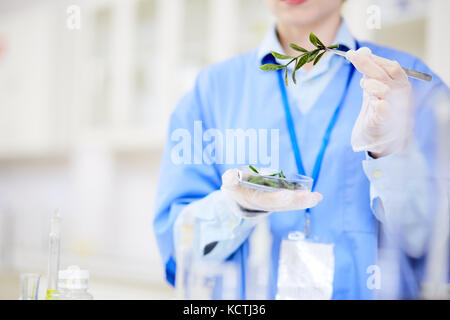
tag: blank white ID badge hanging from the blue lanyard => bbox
[276,231,334,300]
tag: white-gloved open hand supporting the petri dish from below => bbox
[221,169,323,218]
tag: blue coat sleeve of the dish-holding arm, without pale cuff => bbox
[153,73,221,285]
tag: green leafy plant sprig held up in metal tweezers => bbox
[260,32,339,86]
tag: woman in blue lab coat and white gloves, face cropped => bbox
[154,0,449,299]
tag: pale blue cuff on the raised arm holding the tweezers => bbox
[363,140,432,257]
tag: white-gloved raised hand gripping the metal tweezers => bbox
[346,47,413,157]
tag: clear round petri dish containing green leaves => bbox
[238,167,313,191]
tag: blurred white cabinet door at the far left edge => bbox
[0,10,59,157]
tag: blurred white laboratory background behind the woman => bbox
[0,0,450,299]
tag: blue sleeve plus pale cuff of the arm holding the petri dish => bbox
[153,72,256,285]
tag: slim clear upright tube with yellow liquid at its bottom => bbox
[45,210,61,300]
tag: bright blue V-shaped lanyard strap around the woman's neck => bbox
[277,44,358,237]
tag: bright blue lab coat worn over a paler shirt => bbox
[154,42,448,299]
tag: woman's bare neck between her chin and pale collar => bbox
[276,11,341,71]
